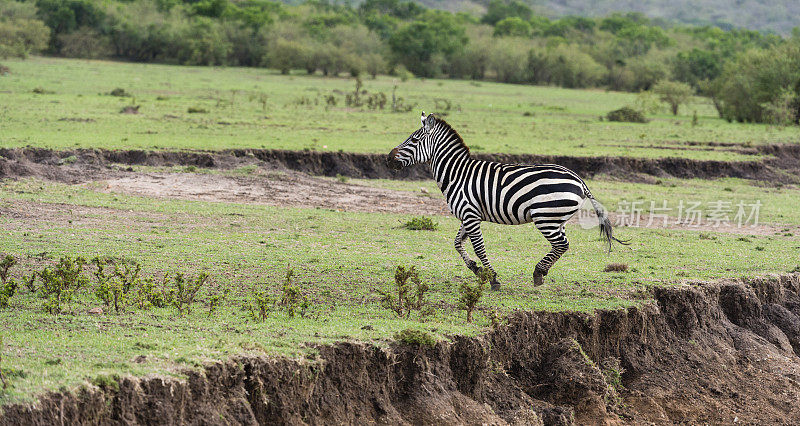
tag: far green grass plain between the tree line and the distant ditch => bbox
[0,58,800,160]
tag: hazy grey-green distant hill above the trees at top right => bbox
[419,0,800,34]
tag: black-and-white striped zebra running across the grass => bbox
[387,111,628,290]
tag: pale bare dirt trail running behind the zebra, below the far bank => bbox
[90,172,800,235]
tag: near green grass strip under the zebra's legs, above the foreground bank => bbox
[0,180,800,404]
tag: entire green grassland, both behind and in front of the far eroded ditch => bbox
[0,58,800,405]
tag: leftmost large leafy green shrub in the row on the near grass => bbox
[38,256,89,314]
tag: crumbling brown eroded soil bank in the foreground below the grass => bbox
[0,275,800,425]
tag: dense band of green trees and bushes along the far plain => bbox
[0,0,800,124]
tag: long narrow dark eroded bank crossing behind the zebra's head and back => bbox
[0,145,800,183]
